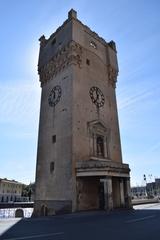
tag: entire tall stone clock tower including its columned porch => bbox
[34,9,130,216]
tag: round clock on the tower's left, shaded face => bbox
[48,85,62,107]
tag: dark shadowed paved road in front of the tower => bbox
[0,203,160,240]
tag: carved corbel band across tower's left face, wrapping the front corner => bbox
[38,41,82,85]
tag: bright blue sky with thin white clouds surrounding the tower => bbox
[0,0,160,185]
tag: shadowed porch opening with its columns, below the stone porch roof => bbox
[77,176,131,211]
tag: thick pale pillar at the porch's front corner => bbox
[104,177,113,210]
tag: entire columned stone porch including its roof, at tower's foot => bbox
[77,160,132,211]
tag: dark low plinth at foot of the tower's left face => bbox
[33,200,72,217]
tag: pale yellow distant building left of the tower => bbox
[0,178,23,202]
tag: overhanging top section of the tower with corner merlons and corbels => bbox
[38,9,118,86]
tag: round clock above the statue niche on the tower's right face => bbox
[89,87,104,107]
